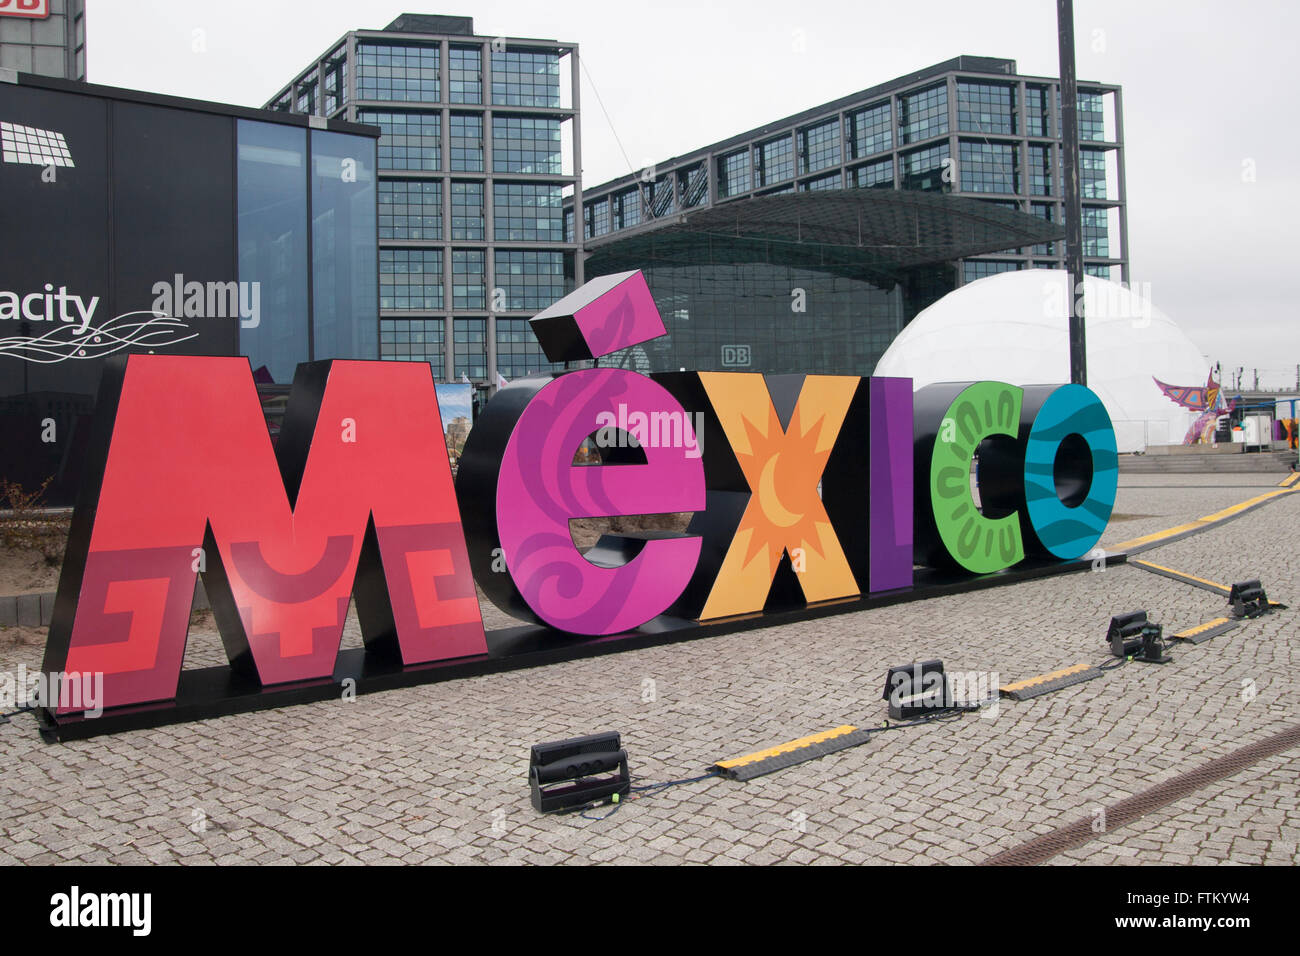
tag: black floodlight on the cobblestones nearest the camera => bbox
[528,731,632,813]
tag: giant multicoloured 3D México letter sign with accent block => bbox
[43,272,1117,736]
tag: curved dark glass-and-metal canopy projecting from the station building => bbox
[586,189,1065,272]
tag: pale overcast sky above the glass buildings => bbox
[87,0,1300,386]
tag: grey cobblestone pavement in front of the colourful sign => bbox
[0,475,1300,864]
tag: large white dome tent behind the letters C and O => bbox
[875,269,1209,451]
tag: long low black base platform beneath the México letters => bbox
[36,554,1126,743]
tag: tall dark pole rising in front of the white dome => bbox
[1057,0,1088,385]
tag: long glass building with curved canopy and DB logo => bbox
[566,56,1128,375]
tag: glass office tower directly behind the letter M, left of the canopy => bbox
[267,14,582,386]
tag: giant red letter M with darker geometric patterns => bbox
[44,355,486,706]
